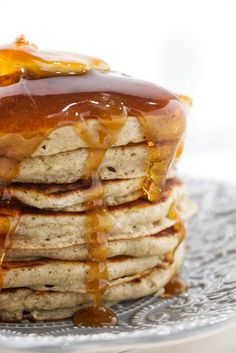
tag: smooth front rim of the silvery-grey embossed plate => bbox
[0,313,236,352]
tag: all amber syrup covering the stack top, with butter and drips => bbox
[0,36,188,326]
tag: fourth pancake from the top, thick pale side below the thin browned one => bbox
[4,179,195,249]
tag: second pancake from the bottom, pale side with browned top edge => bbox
[2,256,169,293]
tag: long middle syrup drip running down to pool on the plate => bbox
[74,94,127,327]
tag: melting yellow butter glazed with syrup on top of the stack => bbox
[0,36,109,86]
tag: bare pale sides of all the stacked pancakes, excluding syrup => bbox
[0,116,194,322]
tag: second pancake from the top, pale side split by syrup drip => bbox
[13,144,177,184]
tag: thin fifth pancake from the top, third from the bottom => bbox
[5,227,181,261]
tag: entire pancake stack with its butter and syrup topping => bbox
[0,36,194,326]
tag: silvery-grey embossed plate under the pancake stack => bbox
[0,180,236,353]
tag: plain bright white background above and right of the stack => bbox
[0,0,236,184]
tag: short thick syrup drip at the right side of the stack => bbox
[140,109,185,202]
